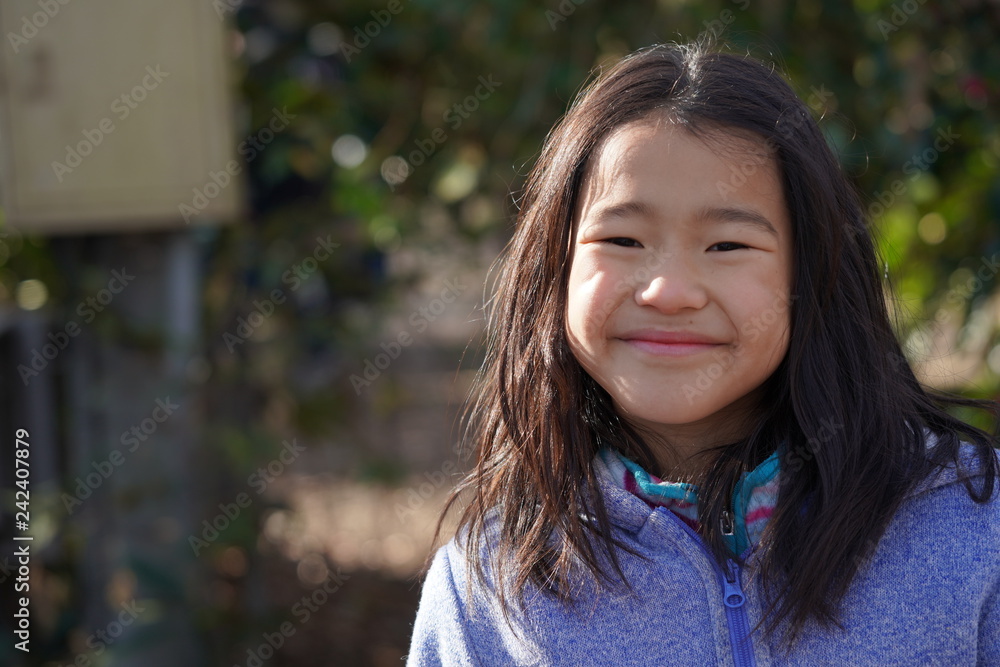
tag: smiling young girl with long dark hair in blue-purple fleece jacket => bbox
[409,45,1000,665]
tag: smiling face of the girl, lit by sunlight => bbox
[566,116,792,460]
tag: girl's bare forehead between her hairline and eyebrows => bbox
[575,113,780,220]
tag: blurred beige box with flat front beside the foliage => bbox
[0,0,245,234]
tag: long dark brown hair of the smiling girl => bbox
[435,44,998,645]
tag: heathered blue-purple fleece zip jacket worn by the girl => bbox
[407,446,1000,667]
